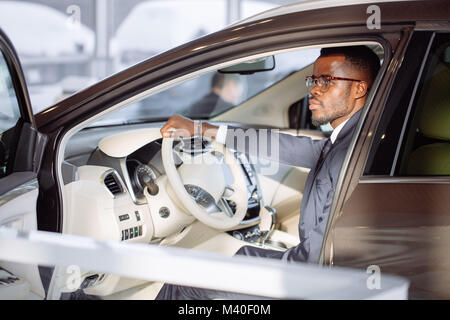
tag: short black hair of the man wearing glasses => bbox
[320,46,380,82]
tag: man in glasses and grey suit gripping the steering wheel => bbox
[157,46,380,299]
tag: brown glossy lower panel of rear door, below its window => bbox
[333,182,450,299]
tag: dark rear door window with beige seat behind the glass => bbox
[396,34,450,176]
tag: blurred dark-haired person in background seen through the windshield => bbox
[188,72,243,119]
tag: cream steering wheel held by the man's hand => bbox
[161,138,248,230]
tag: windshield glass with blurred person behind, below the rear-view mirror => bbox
[93,49,320,126]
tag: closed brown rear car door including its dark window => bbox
[329,29,450,299]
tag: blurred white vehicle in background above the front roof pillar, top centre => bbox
[111,0,276,70]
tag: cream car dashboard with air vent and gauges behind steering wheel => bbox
[63,129,262,243]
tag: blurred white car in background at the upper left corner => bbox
[0,1,97,113]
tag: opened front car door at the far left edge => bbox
[0,30,45,299]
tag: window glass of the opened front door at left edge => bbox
[0,53,20,178]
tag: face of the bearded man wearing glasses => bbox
[309,55,361,128]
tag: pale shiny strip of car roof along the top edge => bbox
[234,0,417,25]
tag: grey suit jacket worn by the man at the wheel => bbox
[226,111,361,263]
